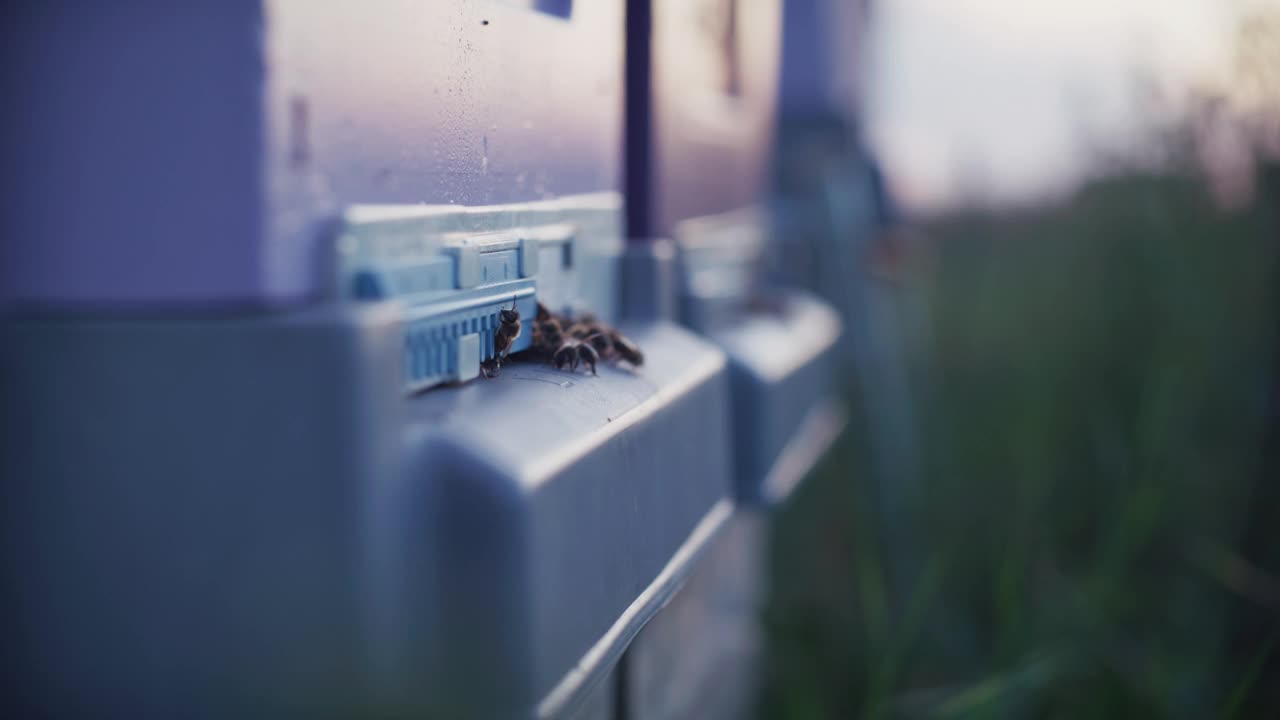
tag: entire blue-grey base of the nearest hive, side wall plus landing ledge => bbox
[0,302,732,717]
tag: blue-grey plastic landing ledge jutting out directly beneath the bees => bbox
[387,324,732,717]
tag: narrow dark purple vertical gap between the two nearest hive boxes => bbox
[622,0,653,238]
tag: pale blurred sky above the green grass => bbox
[865,0,1259,209]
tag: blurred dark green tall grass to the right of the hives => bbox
[763,151,1280,719]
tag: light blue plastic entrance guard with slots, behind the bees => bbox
[337,193,621,392]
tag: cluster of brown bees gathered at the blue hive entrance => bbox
[480,301,644,378]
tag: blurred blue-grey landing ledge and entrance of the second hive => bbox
[676,202,845,505]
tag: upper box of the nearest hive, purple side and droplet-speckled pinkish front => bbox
[0,0,623,304]
